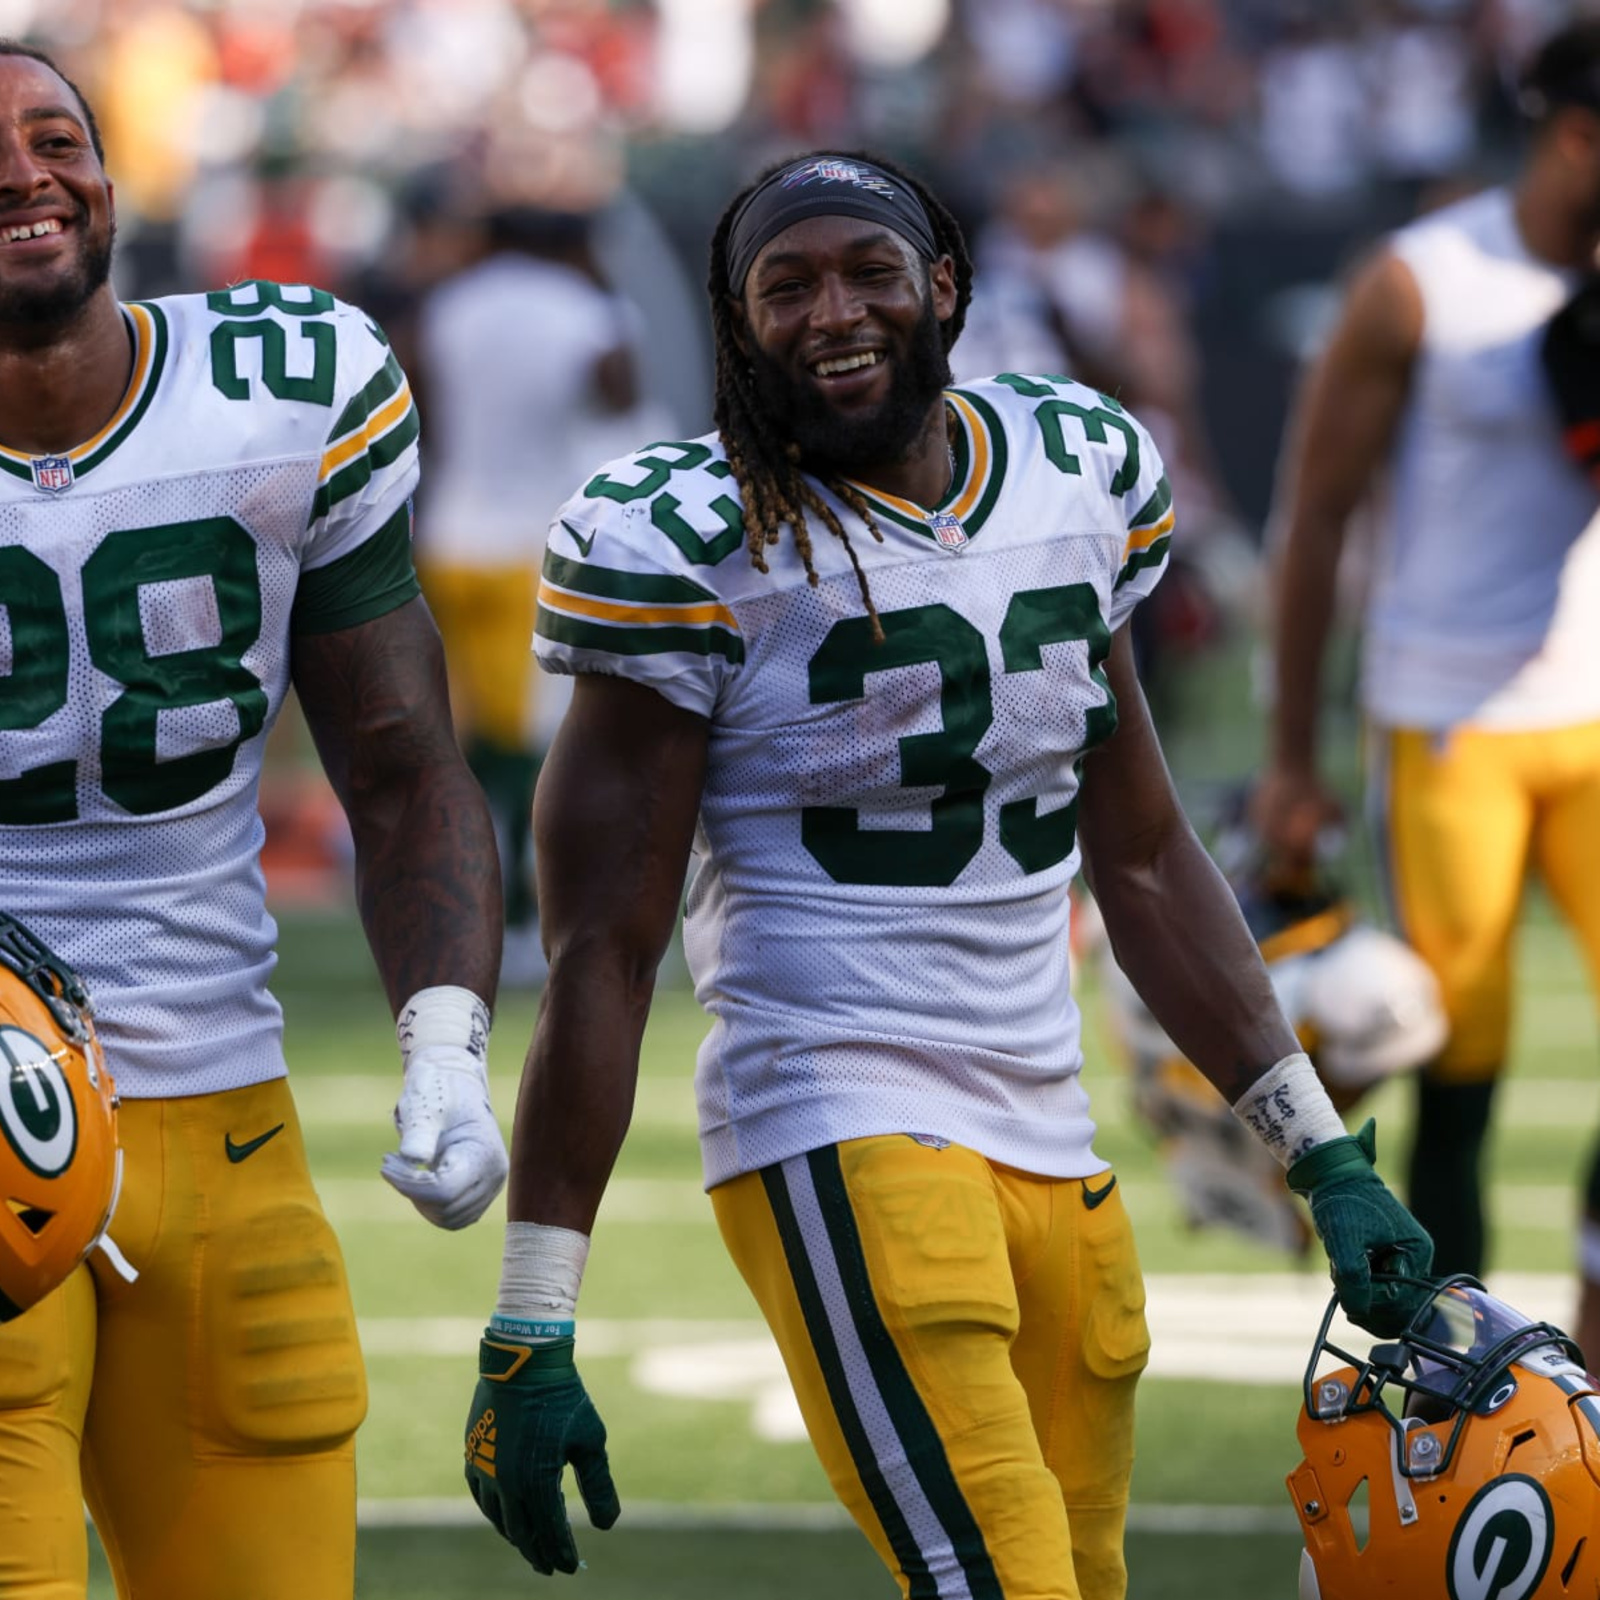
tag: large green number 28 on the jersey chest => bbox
[0,517,267,824]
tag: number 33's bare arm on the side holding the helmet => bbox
[1078,629,1299,1102]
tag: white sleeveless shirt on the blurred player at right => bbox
[1362,189,1600,730]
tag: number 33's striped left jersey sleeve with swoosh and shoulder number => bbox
[534,437,746,717]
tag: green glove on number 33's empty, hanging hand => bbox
[467,1331,622,1573]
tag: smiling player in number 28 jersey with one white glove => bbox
[0,43,506,1600]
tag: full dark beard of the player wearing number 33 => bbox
[750,294,950,477]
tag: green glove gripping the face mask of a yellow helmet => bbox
[1288,1117,1434,1339]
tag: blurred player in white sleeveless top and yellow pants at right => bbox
[1254,19,1600,1362]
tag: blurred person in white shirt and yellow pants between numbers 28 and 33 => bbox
[414,206,662,982]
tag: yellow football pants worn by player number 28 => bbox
[0,1080,366,1600]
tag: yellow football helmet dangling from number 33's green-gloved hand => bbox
[1288,1277,1600,1600]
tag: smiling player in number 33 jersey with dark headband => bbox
[467,152,1429,1600]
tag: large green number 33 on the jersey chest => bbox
[800,584,1117,888]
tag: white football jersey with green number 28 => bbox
[0,283,418,1098]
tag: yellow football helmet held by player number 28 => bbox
[0,912,122,1322]
